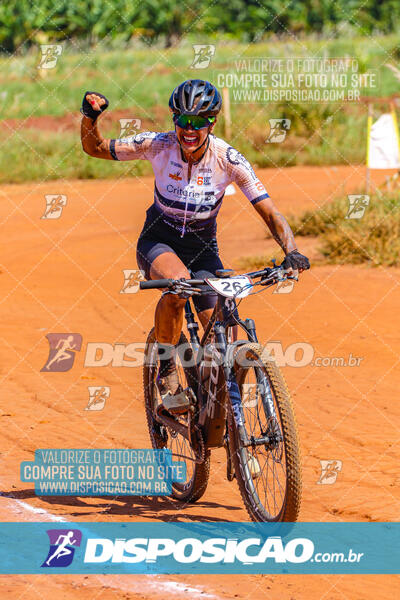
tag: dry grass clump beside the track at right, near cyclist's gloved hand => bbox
[288,194,400,266]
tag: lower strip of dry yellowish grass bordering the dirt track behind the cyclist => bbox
[0,103,365,183]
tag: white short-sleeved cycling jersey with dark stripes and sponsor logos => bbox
[110,131,269,233]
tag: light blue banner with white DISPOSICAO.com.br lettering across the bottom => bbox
[0,522,400,575]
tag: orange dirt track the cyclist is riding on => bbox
[0,167,400,600]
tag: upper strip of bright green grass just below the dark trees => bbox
[0,35,399,119]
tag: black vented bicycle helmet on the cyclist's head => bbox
[169,79,222,117]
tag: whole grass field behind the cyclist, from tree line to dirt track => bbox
[0,36,400,182]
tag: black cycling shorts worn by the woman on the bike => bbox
[136,209,224,312]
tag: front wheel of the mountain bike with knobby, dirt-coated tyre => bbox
[228,343,301,522]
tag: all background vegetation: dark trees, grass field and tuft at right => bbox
[0,0,400,265]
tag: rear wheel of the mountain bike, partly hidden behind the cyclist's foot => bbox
[143,329,210,502]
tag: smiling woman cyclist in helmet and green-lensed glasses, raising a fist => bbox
[81,79,310,412]
